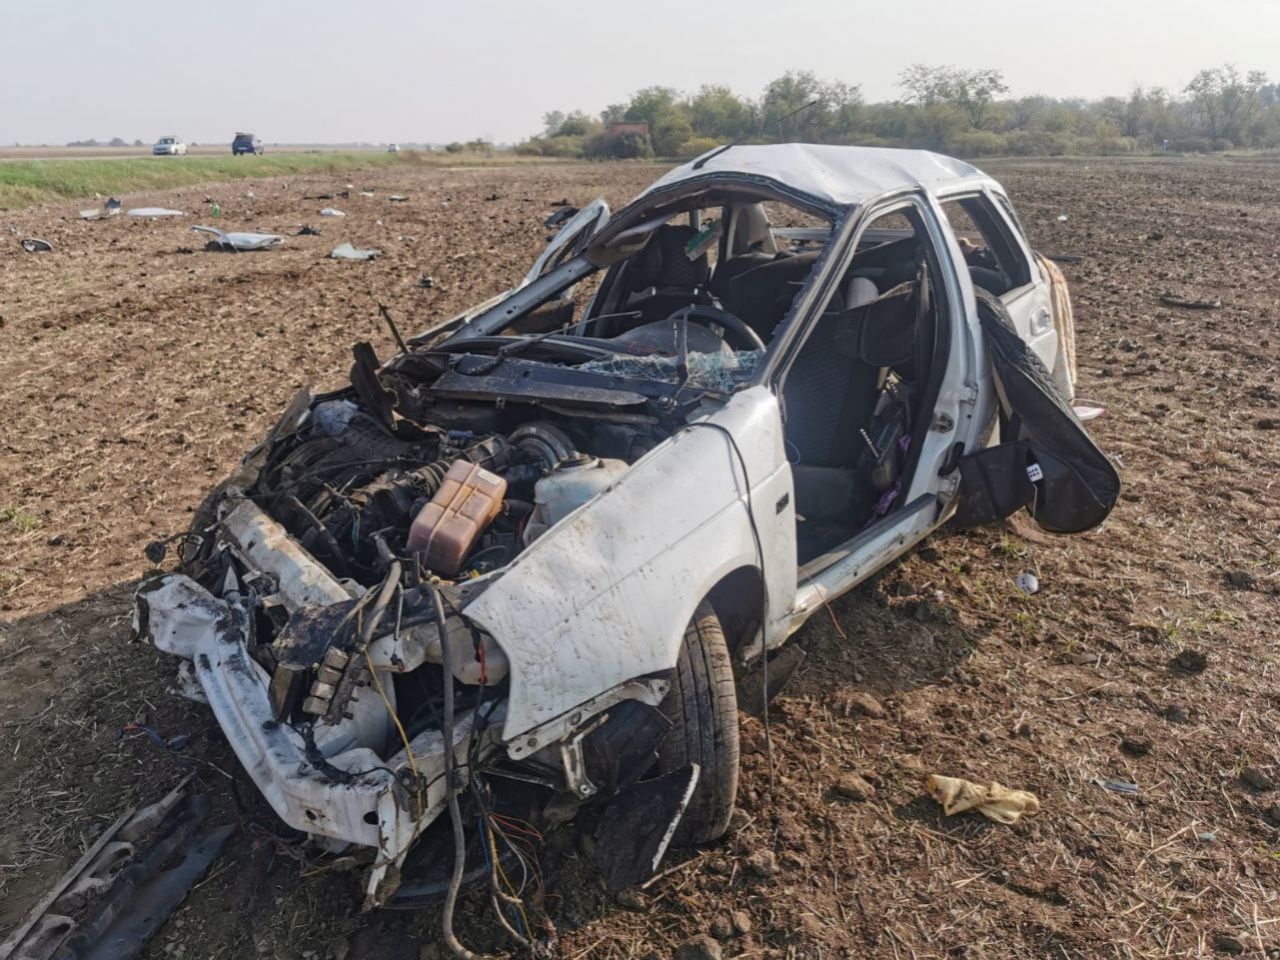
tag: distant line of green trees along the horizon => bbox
[516,64,1280,159]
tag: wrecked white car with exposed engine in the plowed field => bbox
[136,145,1119,905]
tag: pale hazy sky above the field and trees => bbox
[0,0,1280,145]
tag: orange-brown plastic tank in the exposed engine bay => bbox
[408,460,507,576]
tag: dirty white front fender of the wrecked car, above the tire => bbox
[463,387,796,742]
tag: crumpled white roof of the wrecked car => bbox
[641,143,984,209]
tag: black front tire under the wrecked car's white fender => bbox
[658,602,739,844]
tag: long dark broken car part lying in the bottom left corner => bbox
[0,776,234,960]
